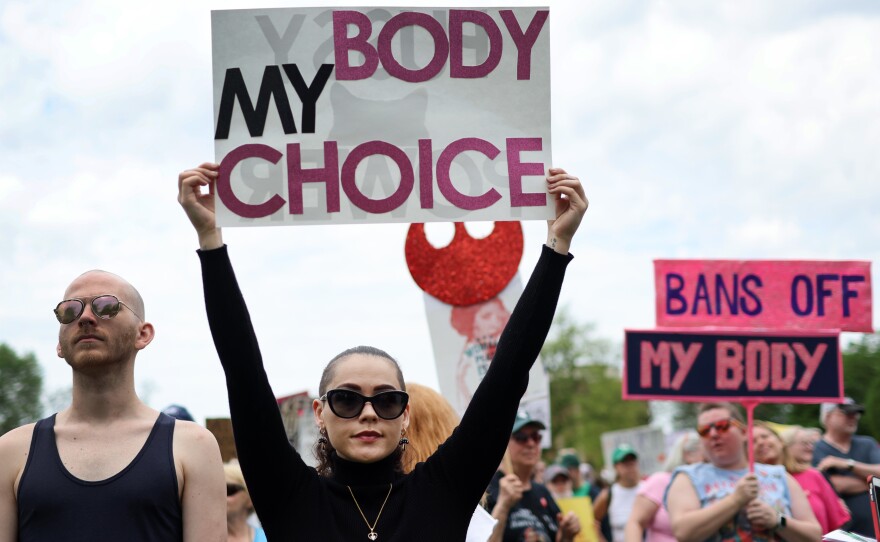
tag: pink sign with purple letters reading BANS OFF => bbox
[654,260,873,333]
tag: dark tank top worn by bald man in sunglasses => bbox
[18,414,183,542]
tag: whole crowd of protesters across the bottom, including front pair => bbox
[0,164,880,542]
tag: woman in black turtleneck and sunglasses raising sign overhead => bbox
[178,163,587,542]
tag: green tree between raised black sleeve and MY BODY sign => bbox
[541,309,650,468]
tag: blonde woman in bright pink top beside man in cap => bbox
[752,421,850,533]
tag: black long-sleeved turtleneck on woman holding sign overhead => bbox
[198,246,571,542]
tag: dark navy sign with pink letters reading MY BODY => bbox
[623,330,843,403]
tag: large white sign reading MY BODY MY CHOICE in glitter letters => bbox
[211,7,554,226]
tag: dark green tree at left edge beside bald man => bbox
[0,343,43,434]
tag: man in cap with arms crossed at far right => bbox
[813,397,880,535]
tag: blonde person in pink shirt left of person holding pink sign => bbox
[624,430,705,542]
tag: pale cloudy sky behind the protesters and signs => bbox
[0,0,880,419]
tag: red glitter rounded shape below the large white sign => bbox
[405,222,523,307]
